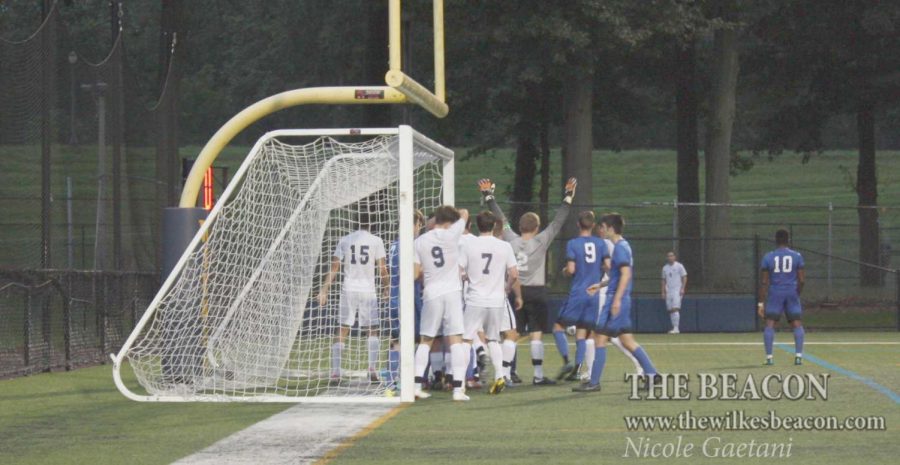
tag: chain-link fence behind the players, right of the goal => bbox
[461,198,900,330]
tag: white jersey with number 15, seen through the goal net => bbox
[334,229,385,293]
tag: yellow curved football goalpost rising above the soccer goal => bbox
[178,0,449,208]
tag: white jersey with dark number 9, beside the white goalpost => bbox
[413,219,466,301]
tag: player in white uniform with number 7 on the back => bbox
[459,211,519,394]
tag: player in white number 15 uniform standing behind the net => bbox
[319,215,390,383]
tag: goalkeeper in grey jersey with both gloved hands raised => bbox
[478,178,578,386]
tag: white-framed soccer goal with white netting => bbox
[113,126,453,402]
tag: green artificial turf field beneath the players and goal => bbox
[0,332,900,465]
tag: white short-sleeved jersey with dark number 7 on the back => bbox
[459,236,516,308]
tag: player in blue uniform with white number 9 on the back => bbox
[553,211,609,381]
